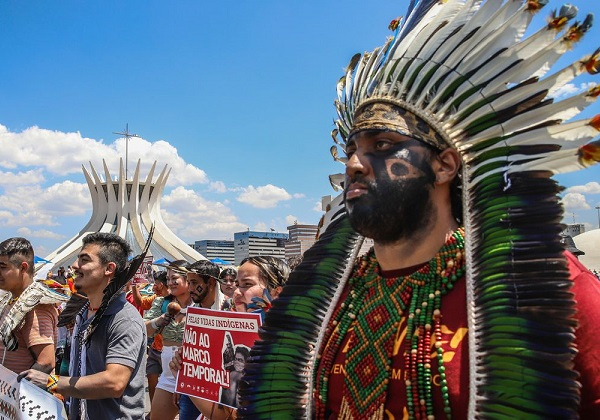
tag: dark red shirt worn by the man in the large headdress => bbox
[327,253,600,419]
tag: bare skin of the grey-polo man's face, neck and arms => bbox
[19,244,133,400]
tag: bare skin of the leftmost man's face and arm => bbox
[0,255,56,373]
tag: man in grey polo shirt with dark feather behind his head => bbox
[23,232,146,420]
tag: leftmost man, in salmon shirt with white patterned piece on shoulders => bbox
[0,238,68,373]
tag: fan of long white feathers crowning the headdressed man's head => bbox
[331,0,600,173]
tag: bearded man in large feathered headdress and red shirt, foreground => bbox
[238,0,600,419]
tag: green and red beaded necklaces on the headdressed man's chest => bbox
[314,228,464,419]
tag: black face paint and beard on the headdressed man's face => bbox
[346,140,435,243]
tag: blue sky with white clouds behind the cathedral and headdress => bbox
[0,0,600,256]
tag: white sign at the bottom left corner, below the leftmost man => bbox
[0,365,67,420]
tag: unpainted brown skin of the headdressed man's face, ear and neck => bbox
[346,131,461,271]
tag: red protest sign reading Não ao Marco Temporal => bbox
[176,307,261,407]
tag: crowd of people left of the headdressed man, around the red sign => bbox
[0,233,289,420]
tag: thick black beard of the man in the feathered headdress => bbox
[346,176,433,244]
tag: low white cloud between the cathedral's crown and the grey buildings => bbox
[161,187,247,242]
